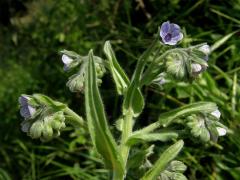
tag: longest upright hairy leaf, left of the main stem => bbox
[85,51,124,174]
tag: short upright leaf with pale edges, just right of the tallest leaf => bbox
[104,41,130,95]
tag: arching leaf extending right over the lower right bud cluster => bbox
[158,102,217,126]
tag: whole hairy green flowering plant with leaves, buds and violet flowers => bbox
[19,21,228,180]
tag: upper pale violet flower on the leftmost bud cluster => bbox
[18,95,36,119]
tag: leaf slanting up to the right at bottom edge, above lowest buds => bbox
[142,140,184,180]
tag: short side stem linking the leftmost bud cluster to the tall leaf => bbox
[64,107,86,128]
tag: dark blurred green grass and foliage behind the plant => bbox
[0,0,240,180]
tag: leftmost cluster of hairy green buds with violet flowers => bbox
[19,95,66,141]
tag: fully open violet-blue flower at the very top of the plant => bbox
[160,21,183,45]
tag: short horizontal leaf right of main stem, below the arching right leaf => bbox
[127,132,178,145]
